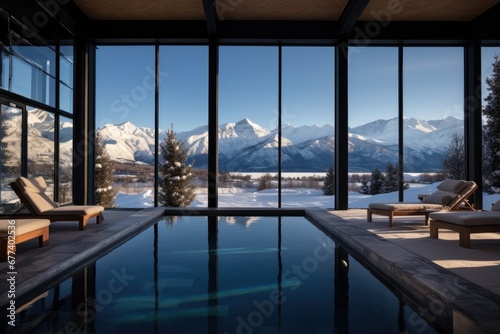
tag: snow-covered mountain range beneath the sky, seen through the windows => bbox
[6,111,463,172]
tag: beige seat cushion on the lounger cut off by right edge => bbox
[429,211,500,226]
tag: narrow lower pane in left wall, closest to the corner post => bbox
[58,117,73,203]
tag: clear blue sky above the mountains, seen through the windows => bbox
[96,46,500,131]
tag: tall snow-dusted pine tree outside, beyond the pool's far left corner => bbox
[159,124,196,207]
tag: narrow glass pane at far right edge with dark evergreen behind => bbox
[481,46,500,210]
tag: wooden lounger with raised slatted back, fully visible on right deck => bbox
[367,179,477,227]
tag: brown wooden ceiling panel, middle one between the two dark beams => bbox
[216,0,347,21]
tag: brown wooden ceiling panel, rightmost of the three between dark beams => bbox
[359,0,500,21]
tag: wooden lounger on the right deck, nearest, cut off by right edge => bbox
[429,201,500,248]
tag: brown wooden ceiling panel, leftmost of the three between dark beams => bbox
[74,0,205,20]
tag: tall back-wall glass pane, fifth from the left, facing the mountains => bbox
[348,47,399,208]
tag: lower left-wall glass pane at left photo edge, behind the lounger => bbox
[0,104,22,214]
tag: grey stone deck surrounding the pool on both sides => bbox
[0,208,500,333]
